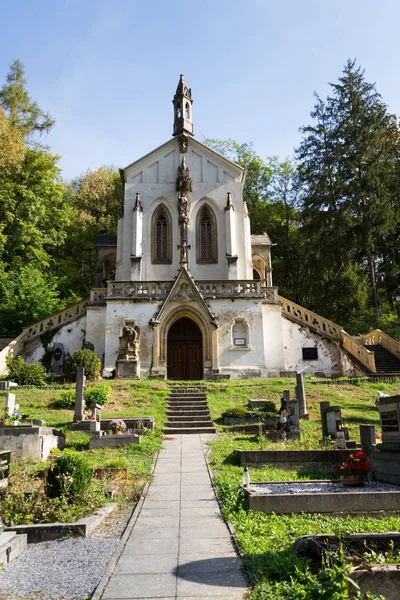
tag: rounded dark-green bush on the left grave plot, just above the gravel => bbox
[45,450,92,502]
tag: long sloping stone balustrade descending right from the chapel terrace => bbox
[278,296,376,373]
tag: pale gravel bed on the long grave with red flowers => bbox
[250,481,400,496]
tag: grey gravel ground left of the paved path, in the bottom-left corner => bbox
[0,506,132,600]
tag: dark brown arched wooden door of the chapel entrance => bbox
[167,317,203,380]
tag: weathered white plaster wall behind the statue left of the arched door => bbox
[104,300,159,374]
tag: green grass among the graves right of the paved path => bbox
[208,378,400,600]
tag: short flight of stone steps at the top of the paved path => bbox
[163,386,215,434]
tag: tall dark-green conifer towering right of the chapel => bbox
[296,61,398,319]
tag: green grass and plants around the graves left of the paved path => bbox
[0,380,168,523]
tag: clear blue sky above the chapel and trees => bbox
[0,0,400,179]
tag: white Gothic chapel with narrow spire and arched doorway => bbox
[16,75,366,380]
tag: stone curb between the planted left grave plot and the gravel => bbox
[4,502,117,544]
